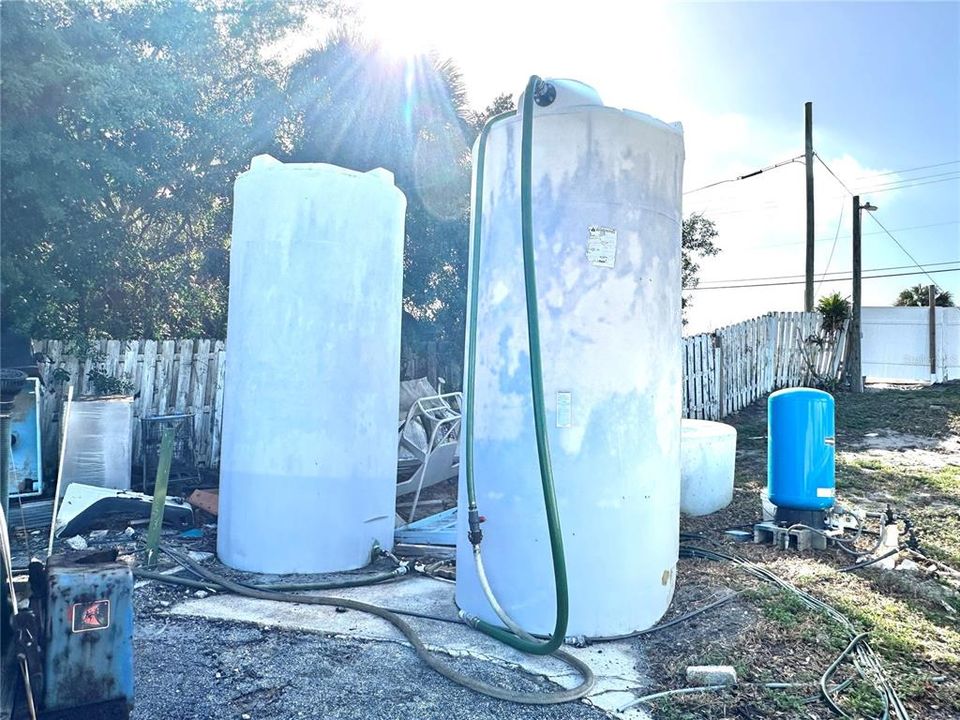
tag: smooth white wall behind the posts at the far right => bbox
[861,307,960,382]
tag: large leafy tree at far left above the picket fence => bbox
[0,0,322,337]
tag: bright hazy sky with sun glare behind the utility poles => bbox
[304,0,960,332]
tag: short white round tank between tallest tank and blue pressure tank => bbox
[680,419,737,516]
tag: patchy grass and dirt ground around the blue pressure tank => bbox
[668,383,960,720]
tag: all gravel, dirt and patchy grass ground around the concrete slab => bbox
[9,383,960,720]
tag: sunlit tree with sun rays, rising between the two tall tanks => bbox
[284,32,476,341]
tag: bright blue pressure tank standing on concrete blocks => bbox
[767,388,836,511]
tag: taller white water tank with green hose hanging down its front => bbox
[456,81,683,636]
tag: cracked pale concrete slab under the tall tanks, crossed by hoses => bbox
[165,577,650,720]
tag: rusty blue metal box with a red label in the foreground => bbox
[41,553,133,717]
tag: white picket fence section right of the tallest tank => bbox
[683,312,847,420]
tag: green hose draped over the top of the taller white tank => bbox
[465,75,569,655]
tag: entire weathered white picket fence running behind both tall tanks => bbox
[33,313,846,468]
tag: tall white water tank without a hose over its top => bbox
[217,155,406,573]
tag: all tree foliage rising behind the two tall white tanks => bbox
[0,0,717,344]
